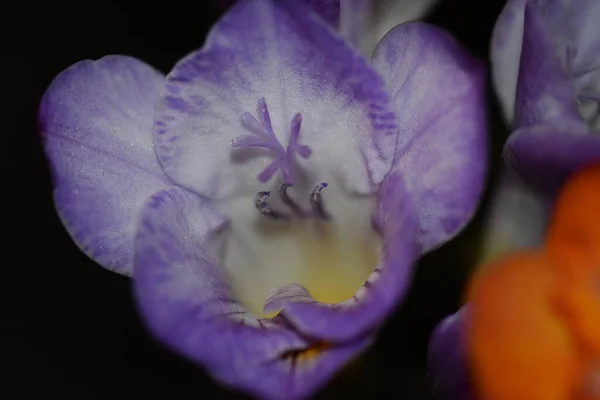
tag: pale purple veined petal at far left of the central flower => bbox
[38,56,171,274]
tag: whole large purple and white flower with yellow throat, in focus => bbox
[40,0,487,399]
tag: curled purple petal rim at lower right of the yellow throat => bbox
[265,173,418,341]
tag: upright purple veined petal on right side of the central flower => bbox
[373,22,488,252]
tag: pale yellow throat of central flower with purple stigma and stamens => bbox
[221,99,380,315]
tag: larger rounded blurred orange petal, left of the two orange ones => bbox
[466,253,582,400]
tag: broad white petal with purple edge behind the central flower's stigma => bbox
[155,0,397,198]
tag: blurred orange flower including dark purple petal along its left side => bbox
[430,163,600,400]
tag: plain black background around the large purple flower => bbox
[11,0,505,400]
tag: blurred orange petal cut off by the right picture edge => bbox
[546,164,600,356]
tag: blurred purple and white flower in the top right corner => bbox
[491,0,600,195]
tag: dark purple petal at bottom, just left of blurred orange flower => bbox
[428,306,477,400]
